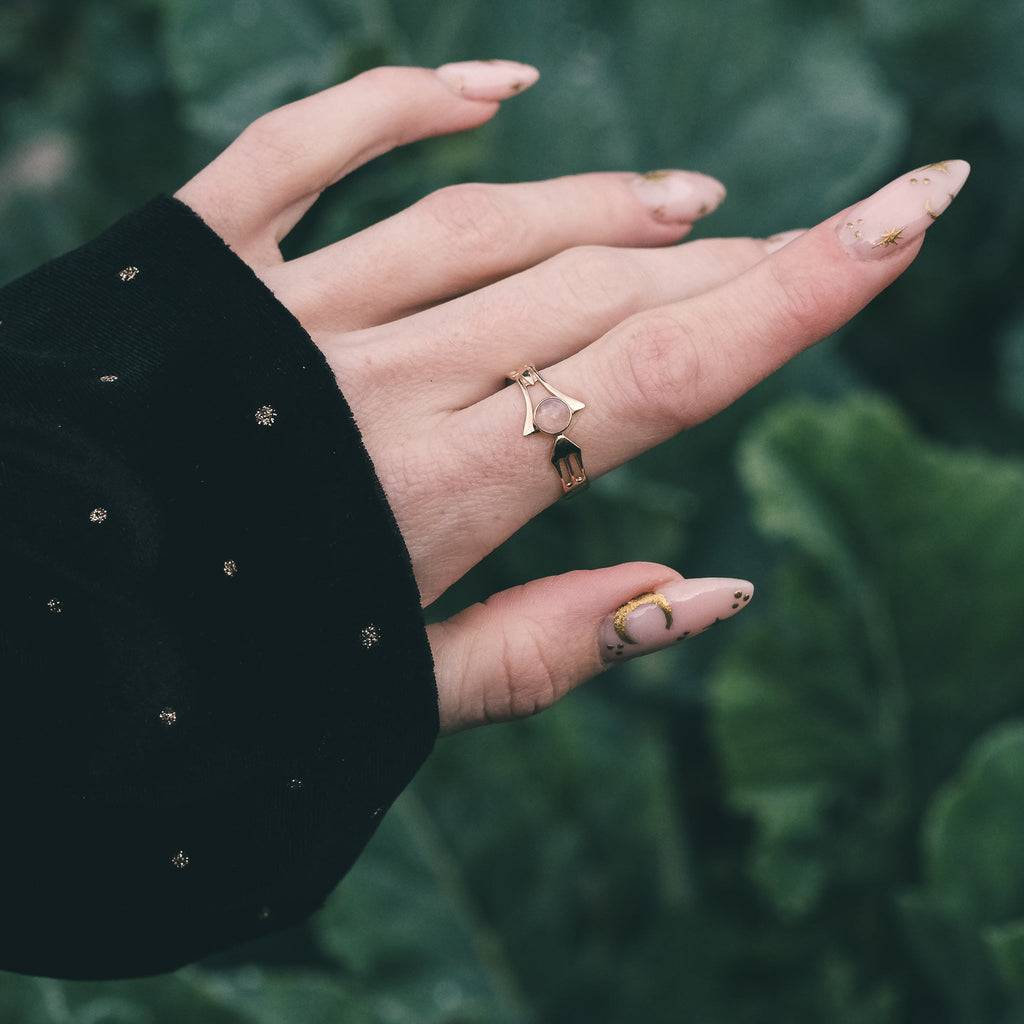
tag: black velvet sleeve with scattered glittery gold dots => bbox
[0,198,437,978]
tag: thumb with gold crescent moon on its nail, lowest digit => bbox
[427,562,754,734]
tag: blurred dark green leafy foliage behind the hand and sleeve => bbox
[0,0,1024,1024]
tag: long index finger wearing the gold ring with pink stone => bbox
[460,161,969,503]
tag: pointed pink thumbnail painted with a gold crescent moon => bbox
[598,578,754,663]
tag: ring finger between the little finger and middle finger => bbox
[265,171,725,331]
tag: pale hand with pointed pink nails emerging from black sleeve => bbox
[178,61,968,731]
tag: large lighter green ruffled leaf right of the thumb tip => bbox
[713,398,1024,913]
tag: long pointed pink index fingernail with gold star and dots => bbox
[837,160,971,259]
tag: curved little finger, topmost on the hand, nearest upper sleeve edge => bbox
[177,61,537,265]
